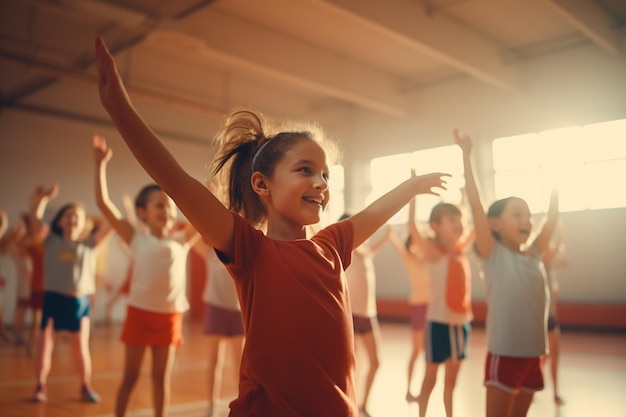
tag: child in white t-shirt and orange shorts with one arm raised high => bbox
[92,135,196,417]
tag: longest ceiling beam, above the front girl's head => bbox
[157,10,406,118]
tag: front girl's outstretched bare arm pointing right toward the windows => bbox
[350,173,448,249]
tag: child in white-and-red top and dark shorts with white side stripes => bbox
[400,171,472,417]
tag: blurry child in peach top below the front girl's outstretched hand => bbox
[390,198,430,401]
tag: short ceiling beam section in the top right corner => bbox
[544,0,622,55]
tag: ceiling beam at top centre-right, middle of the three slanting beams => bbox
[320,0,517,91]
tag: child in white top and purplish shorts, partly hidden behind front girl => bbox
[339,213,390,417]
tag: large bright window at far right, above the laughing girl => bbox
[493,120,626,213]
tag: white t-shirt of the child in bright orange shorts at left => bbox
[128,230,190,313]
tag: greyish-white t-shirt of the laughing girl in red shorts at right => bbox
[479,241,549,357]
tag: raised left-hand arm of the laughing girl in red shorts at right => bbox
[454,129,494,258]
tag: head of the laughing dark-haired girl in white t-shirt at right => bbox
[489,198,532,250]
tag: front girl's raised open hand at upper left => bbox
[95,36,130,114]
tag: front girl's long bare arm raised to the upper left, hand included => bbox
[95,37,234,257]
